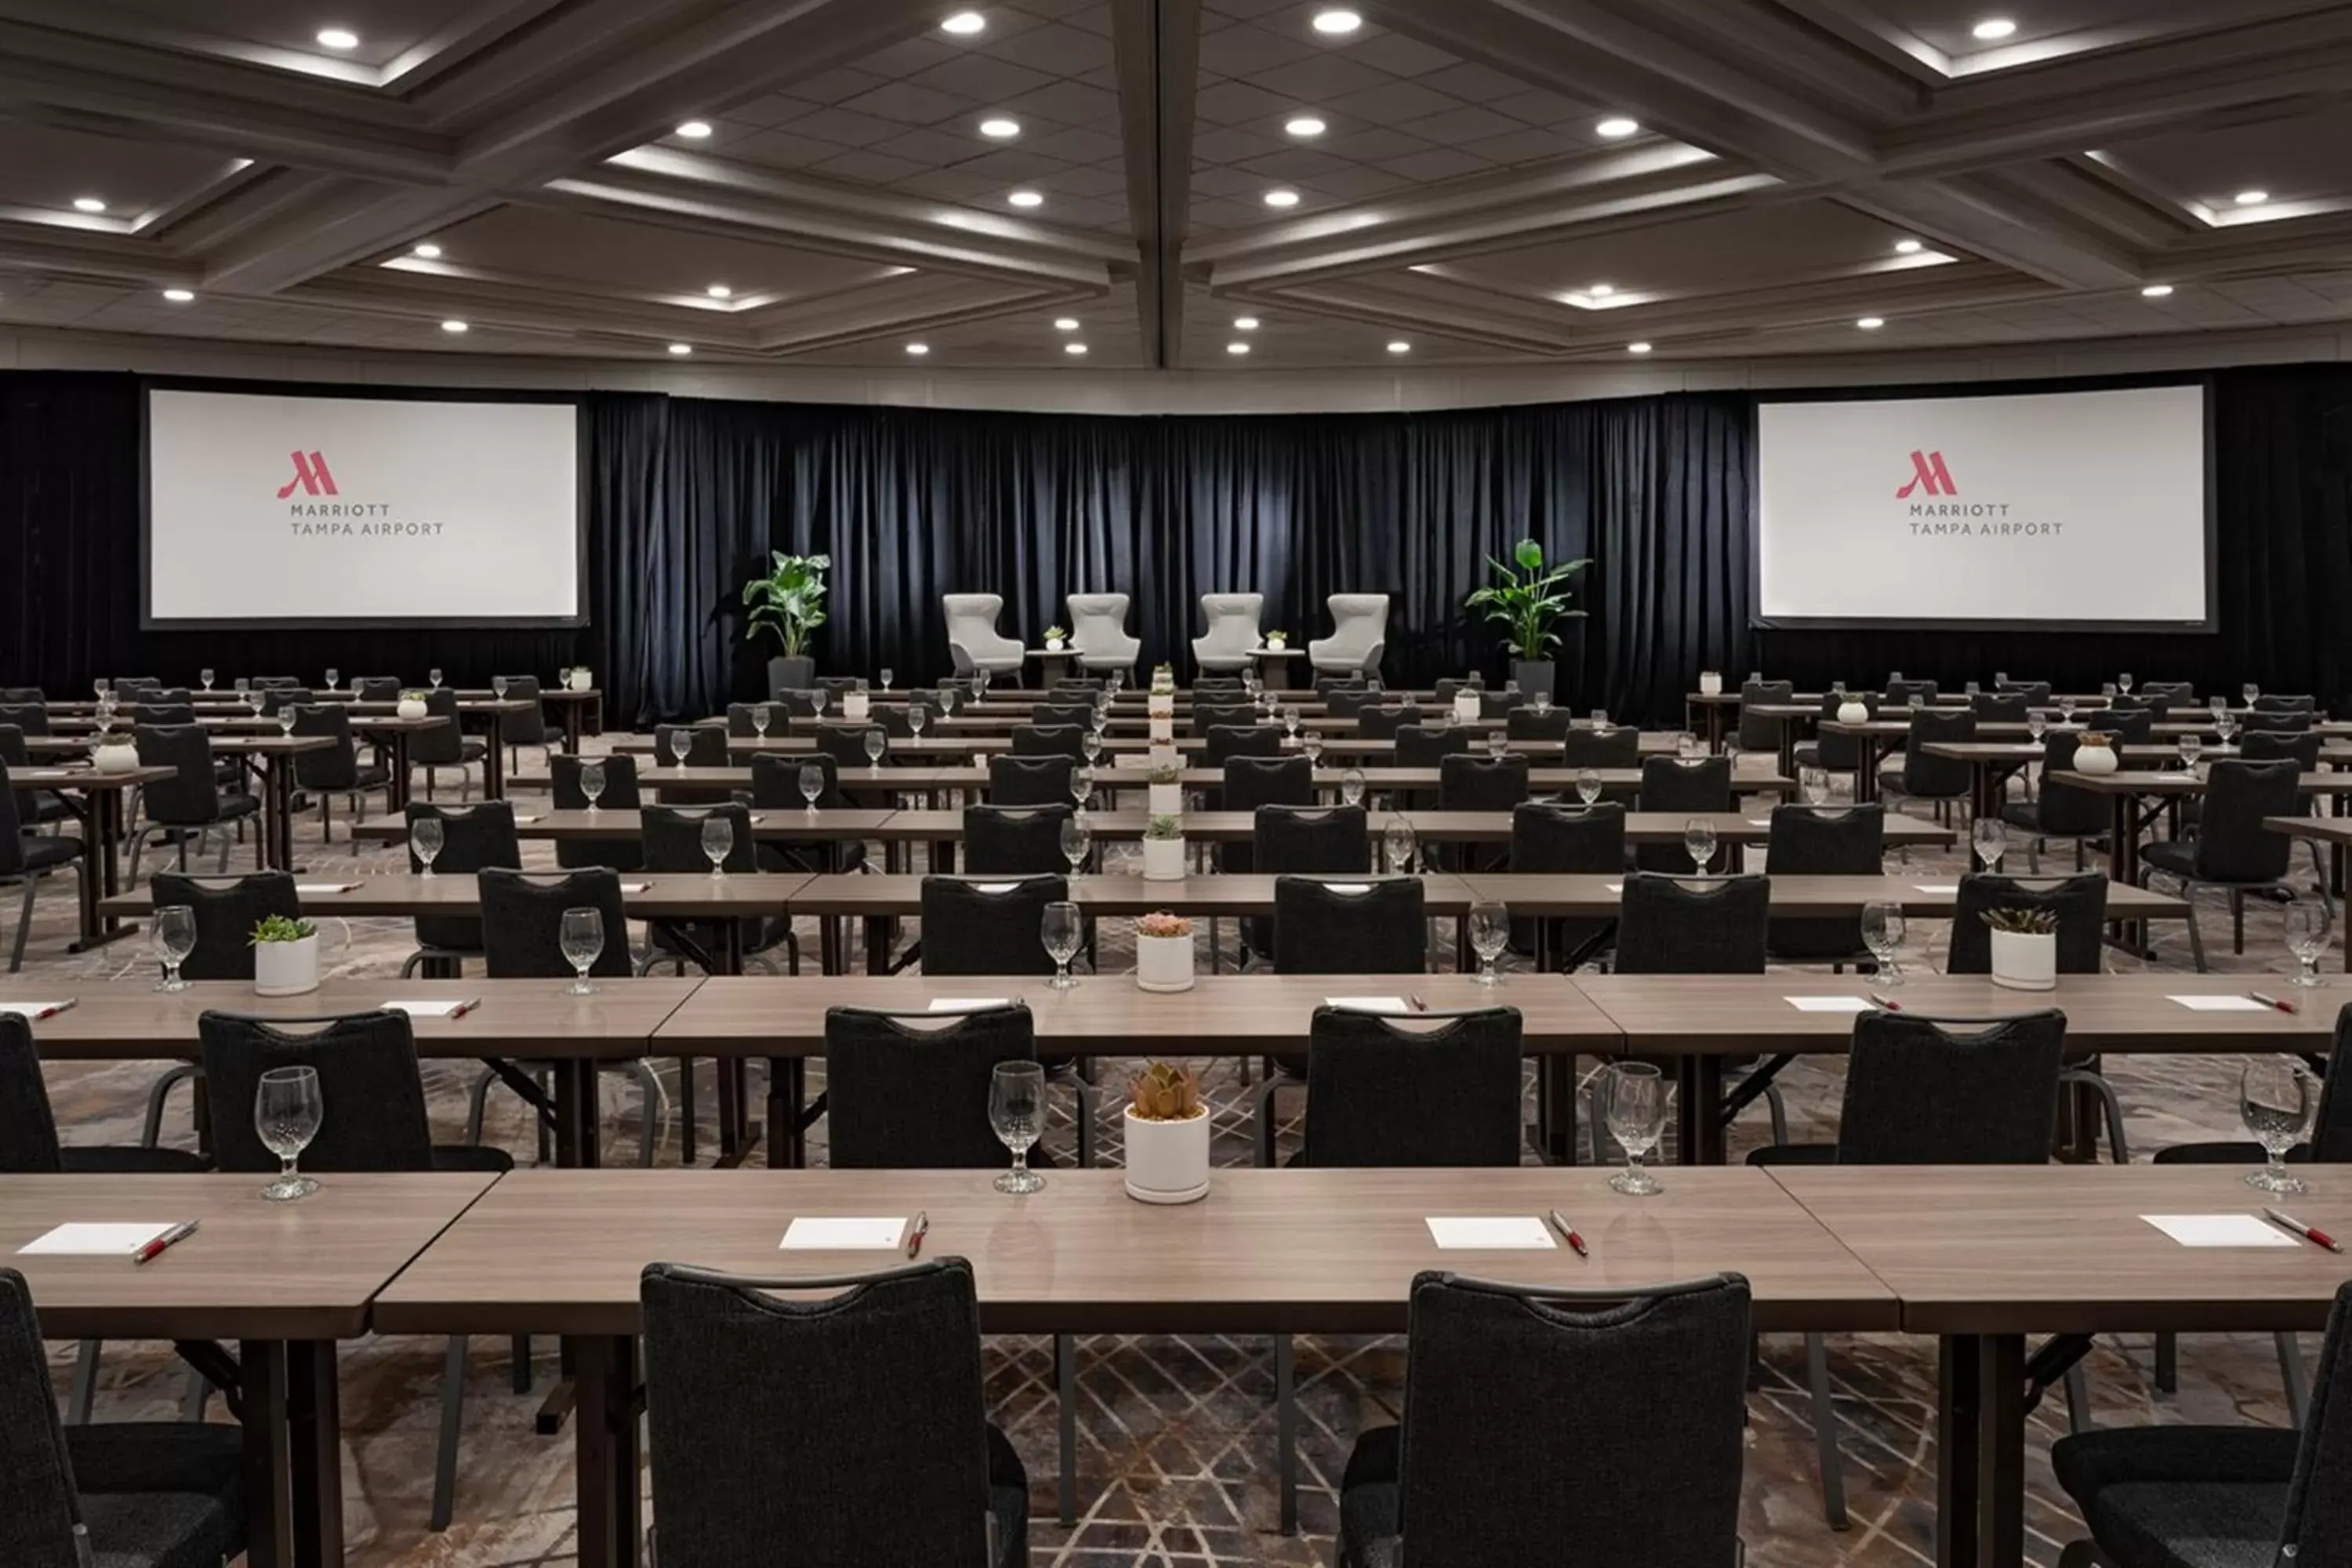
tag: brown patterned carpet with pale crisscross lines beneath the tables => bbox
[26,742,2336,1568]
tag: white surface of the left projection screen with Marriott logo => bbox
[146,388,581,628]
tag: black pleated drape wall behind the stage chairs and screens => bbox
[0,367,2352,722]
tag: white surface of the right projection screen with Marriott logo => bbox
[1755,383,2213,630]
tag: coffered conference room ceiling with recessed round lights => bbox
[0,0,2352,372]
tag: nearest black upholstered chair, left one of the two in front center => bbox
[640,1258,1028,1568]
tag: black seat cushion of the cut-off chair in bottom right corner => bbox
[2051,1427,2303,1568]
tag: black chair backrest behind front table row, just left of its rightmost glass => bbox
[1837,1008,2065,1166]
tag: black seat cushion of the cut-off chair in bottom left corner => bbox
[66,1422,245,1568]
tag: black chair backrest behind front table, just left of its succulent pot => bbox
[826,1001,1037,1171]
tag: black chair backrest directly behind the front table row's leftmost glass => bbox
[195,1008,433,1171]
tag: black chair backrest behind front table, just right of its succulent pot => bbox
[1308,1006,1524,1166]
